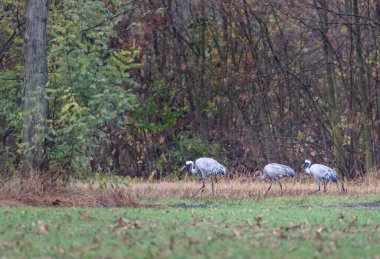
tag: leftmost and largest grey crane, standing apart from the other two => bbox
[181,157,227,196]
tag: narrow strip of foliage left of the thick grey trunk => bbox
[0,0,24,175]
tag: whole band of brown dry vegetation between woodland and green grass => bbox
[0,171,380,207]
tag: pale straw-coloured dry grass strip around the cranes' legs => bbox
[131,173,380,200]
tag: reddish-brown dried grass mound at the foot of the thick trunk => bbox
[0,174,139,207]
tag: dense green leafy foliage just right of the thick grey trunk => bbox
[48,1,135,176]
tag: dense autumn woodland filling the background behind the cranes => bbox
[0,0,380,183]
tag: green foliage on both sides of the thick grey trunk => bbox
[0,0,140,178]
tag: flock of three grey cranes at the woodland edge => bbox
[181,157,338,196]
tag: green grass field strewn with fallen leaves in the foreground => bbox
[0,196,380,258]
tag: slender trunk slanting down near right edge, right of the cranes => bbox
[353,0,373,172]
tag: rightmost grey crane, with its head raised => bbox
[303,159,338,192]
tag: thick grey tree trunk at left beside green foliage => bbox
[24,0,49,176]
